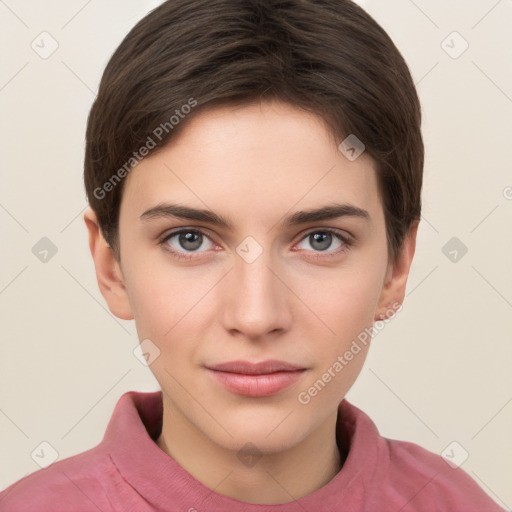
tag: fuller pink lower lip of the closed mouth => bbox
[209,370,305,397]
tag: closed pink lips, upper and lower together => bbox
[207,360,306,397]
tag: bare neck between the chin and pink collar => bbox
[157,399,343,505]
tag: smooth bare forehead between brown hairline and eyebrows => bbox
[121,102,380,221]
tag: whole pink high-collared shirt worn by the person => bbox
[0,391,503,512]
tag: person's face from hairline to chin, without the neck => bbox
[86,102,414,453]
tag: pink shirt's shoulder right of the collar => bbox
[381,438,503,512]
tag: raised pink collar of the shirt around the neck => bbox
[102,391,379,512]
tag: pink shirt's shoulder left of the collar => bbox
[0,447,117,512]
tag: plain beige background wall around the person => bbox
[0,0,512,509]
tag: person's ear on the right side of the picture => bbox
[375,220,419,321]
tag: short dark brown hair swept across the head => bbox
[84,0,424,262]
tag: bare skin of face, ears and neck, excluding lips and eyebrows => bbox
[84,102,418,504]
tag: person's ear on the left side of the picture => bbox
[84,207,134,320]
